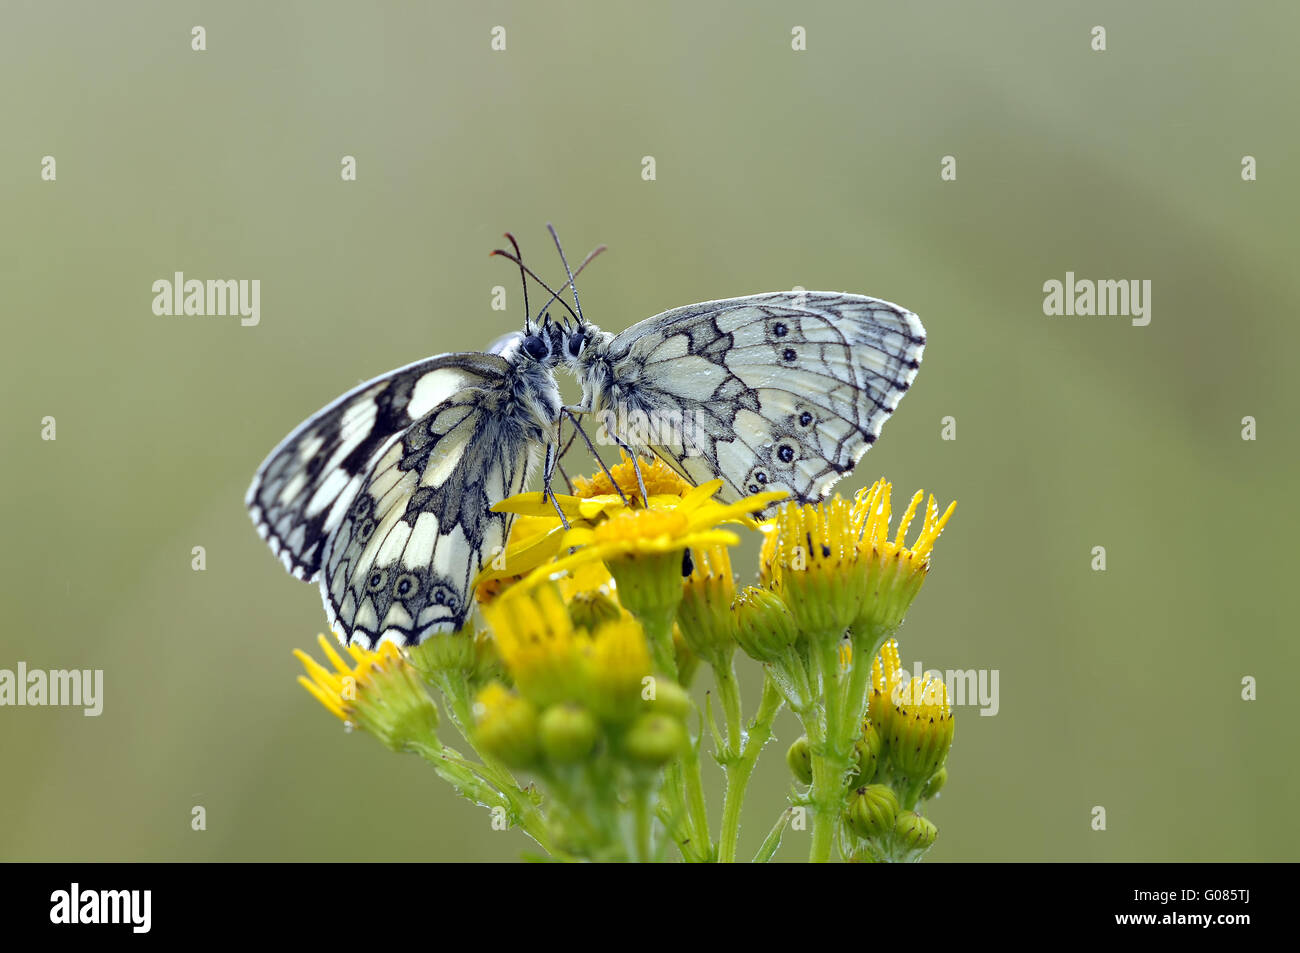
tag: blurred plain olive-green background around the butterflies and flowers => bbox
[0,0,1300,861]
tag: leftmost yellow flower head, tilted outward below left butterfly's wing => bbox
[294,636,438,749]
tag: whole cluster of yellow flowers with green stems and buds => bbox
[299,459,953,862]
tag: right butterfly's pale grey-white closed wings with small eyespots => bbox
[588,291,926,502]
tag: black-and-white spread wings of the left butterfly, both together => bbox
[246,354,537,647]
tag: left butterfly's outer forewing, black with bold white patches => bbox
[244,354,517,581]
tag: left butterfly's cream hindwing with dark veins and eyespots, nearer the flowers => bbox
[321,371,538,647]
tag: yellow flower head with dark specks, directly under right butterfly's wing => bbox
[759,495,866,638]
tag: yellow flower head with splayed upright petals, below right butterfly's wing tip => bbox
[852,480,957,632]
